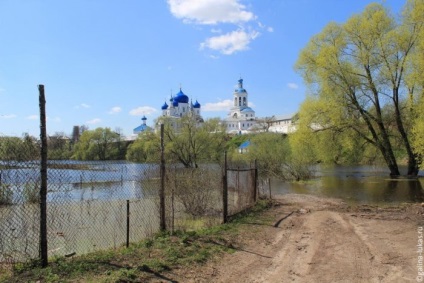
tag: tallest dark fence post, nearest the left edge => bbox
[38,85,48,267]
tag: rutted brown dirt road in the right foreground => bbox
[167,195,424,283]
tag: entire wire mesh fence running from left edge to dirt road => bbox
[0,137,256,270]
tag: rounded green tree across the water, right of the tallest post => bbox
[73,128,121,160]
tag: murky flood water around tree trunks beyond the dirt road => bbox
[271,166,424,205]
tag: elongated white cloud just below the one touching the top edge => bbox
[200,30,259,55]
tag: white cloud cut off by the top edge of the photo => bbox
[168,0,256,25]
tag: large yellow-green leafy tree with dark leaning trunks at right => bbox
[296,0,424,175]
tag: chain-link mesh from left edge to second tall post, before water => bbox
[0,152,159,263]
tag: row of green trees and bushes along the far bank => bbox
[0,117,313,180]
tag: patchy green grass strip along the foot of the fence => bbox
[0,200,271,283]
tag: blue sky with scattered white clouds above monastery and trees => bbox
[0,0,405,137]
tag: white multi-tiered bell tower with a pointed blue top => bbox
[224,78,256,134]
